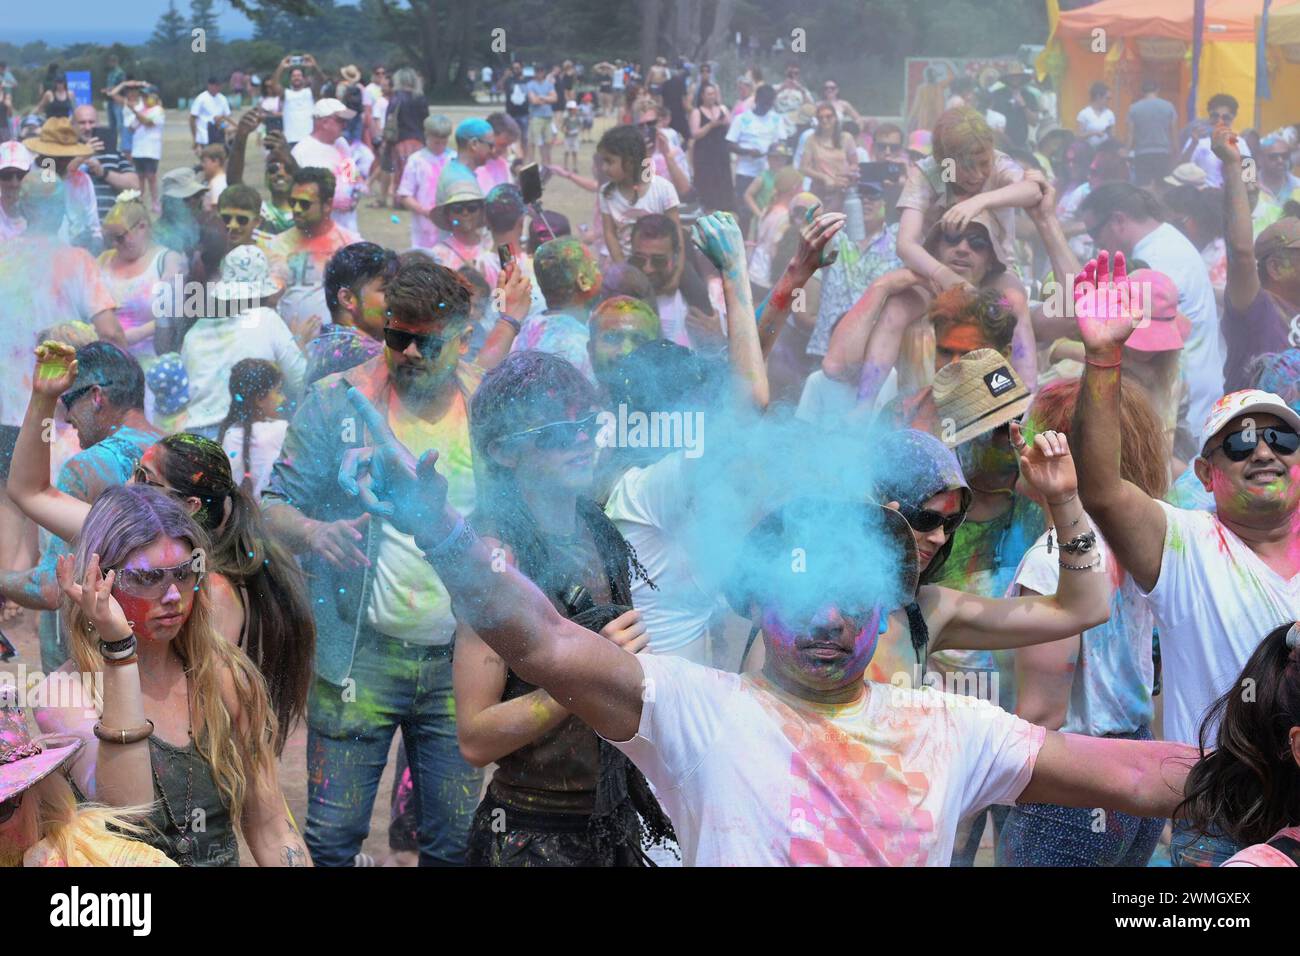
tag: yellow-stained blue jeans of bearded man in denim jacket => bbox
[306,631,482,866]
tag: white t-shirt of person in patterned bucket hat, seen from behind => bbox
[181,307,307,428]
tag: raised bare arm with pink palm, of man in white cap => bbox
[1071,252,1165,591]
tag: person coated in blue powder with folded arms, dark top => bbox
[454,351,671,866]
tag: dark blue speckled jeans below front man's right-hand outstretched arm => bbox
[997,727,1165,866]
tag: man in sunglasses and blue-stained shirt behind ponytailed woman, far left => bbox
[0,342,163,671]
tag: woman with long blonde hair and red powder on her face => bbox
[36,484,309,866]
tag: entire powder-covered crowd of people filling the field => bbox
[0,41,1300,866]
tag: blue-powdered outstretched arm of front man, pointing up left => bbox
[339,389,644,740]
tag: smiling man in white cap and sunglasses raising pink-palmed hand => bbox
[1071,254,1300,865]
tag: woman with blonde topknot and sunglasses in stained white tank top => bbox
[99,190,185,363]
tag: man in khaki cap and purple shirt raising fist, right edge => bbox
[1214,126,1300,389]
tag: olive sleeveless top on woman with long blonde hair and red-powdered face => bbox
[142,734,239,866]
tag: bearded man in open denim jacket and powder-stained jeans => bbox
[264,255,482,866]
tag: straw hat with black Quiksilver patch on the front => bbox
[933,349,1030,447]
